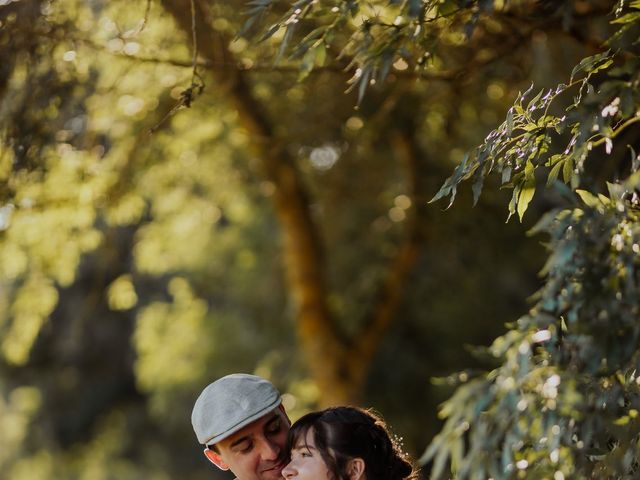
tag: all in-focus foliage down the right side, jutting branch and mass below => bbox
[423,2,640,479]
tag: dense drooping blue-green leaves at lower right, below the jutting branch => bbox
[425,183,640,478]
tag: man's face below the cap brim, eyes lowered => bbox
[205,407,291,480]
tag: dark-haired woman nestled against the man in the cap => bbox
[282,407,417,480]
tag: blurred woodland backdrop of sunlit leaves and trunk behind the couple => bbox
[0,0,603,480]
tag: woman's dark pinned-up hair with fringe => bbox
[286,407,417,480]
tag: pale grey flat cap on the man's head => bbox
[191,373,282,445]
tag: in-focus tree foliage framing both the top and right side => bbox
[241,1,640,479]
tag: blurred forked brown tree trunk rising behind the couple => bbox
[162,0,422,406]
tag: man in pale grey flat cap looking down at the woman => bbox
[191,373,291,480]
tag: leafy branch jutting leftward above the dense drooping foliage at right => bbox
[433,47,638,220]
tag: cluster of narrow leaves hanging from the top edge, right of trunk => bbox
[242,0,505,102]
